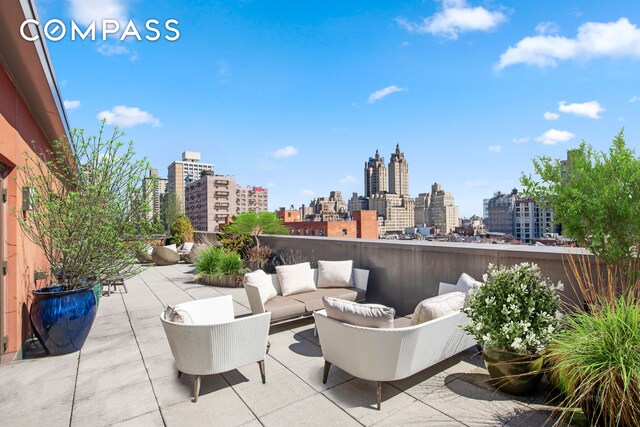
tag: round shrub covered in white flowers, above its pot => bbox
[463,263,563,354]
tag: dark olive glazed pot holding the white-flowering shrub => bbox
[482,347,544,395]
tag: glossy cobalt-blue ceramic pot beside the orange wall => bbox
[29,285,97,356]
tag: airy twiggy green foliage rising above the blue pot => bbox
[14,122,153,287]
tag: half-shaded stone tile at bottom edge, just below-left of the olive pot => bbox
[421,379,527,426]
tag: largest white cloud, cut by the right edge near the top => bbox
[495,18,640,70]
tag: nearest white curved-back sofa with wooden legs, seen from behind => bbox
[314,283,476,410]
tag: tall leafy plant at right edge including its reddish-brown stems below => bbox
[521,131,640,305]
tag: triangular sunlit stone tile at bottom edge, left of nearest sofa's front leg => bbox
[260,394,360,427]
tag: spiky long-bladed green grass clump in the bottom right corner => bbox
[548,297,640,426]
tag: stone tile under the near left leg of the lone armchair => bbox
[153,374,230,408]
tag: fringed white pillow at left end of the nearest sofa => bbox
[322,297,396,328]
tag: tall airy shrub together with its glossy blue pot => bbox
[14,122,153,355]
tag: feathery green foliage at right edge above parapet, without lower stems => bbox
[521,131,640,264]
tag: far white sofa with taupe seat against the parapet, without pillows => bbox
[244,268,369,323]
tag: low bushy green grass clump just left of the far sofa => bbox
[194,246,249,287]
